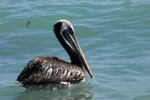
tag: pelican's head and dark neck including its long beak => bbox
[54,19,93,78]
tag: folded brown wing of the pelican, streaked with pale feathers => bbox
[17,56,85,84]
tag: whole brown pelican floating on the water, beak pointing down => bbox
[17,20,93,89]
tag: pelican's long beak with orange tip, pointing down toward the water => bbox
[63,30,93,78]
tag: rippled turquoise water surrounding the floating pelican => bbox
[0,0,150,100]
